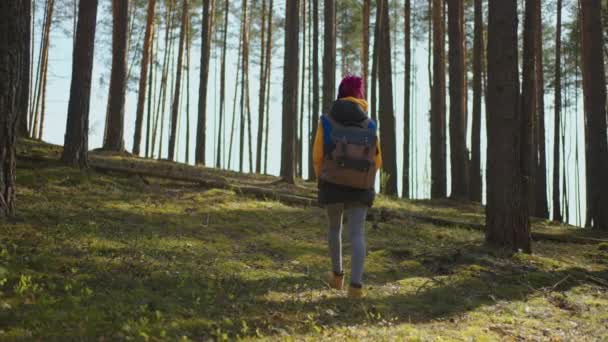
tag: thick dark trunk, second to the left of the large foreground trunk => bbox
[448,0,468,199]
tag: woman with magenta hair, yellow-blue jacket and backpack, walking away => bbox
[313,76,382,299]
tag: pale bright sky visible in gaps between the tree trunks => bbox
[39,4,585,224]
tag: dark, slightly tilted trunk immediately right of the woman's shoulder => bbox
[378,0,398,196]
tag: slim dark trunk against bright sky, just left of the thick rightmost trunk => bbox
[553,0,563,222]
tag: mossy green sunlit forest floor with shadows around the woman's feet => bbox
[0,141,608,341]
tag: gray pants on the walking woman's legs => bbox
[327,204,367,285]
